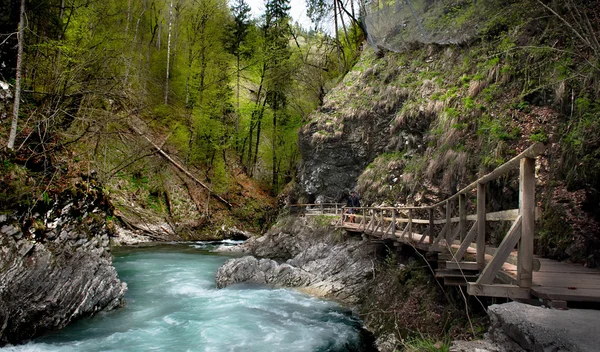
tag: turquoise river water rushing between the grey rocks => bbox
[0,242,373,352]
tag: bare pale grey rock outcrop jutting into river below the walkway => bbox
[215,218,375,303]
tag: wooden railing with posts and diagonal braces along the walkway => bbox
[288,143,545,298]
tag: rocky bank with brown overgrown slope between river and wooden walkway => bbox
[216,216,485,352]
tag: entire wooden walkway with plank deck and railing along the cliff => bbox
[291,143,600,308]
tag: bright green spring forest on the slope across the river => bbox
[0,0,362,216]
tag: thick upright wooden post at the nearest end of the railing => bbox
[517,158,535,287]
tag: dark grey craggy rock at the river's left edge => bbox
[0,184,127,346]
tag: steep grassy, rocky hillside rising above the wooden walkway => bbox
[296,1,600,266]
